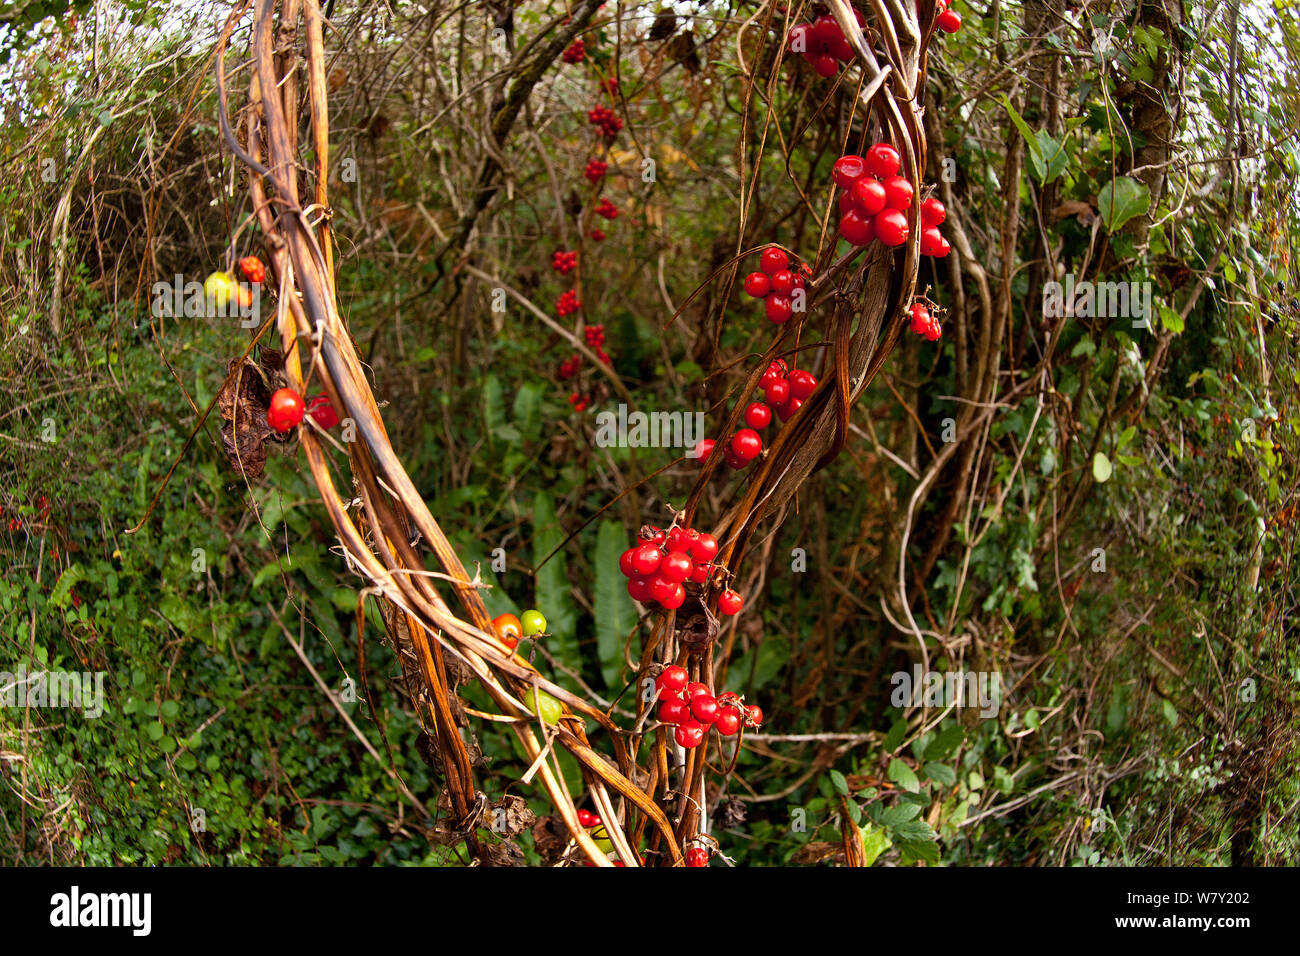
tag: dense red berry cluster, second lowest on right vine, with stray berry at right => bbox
[619,528,757,614]
